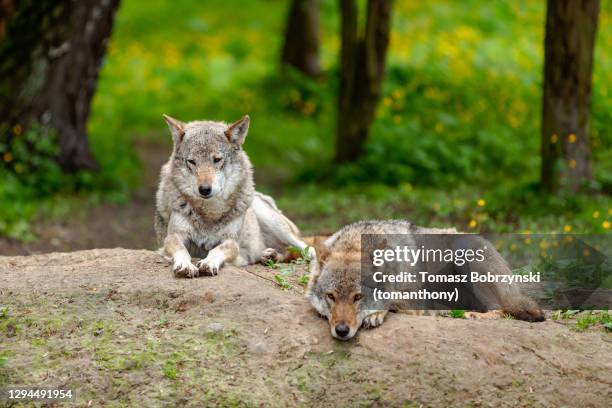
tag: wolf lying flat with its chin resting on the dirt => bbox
[306,221,544,340]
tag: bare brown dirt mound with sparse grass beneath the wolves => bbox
[0,249,612,407]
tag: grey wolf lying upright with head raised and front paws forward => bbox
[155,115,314,277]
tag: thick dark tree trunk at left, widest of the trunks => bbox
[0,0,119,171]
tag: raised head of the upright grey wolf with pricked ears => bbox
[164,115,251,202]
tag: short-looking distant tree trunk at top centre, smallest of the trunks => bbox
[281,0,321,78]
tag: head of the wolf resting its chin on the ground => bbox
[306,242,372,340]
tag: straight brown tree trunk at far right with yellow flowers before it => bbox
[541,0,599,192]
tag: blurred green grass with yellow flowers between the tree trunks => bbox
[0,0,612,239]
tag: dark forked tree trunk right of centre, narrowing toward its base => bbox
[335,0,391,163]
